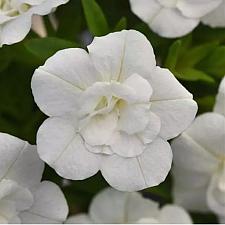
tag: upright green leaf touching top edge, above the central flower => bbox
[82,0,109,36]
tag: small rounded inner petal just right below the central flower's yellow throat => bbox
[118,104,150,135]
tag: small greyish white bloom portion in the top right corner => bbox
[201,0,225,27]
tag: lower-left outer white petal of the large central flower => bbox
[37,118,100,180]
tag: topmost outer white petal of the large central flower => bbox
[88,30,156,81]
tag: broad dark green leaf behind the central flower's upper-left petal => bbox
[24,37,77,61]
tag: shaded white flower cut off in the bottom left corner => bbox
[0,133,68,223]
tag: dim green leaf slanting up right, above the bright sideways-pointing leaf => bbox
[177,42,218,68]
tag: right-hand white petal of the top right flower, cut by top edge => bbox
[177,0,222,18]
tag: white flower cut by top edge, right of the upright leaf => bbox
[130,0,222,38]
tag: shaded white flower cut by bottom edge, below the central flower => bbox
[66,188,192,224]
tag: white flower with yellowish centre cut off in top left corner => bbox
[0,0,69,46]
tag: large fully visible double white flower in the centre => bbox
[32,30,197,191]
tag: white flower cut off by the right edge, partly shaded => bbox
[172,78,225,217]
